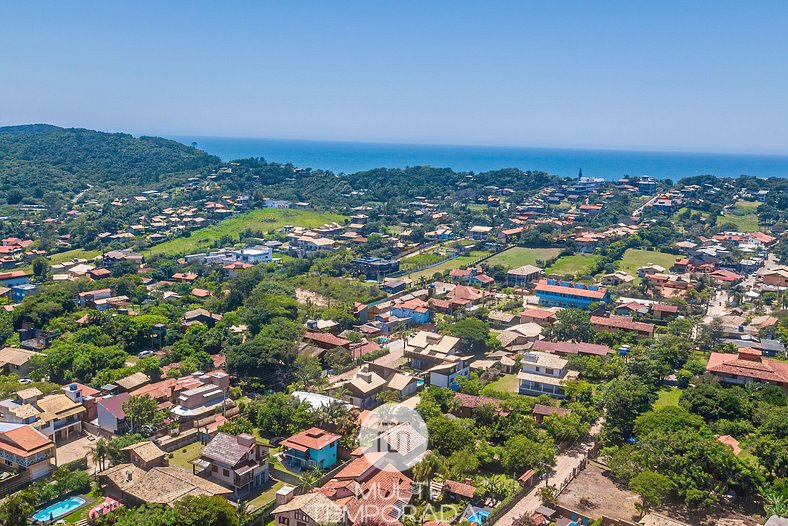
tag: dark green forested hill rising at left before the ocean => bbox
[0,124,220,204]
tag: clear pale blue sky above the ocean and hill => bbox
[0,0,788,153]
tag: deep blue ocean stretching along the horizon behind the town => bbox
[169,136,788,181]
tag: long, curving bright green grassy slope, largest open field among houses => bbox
[150,208,346,255]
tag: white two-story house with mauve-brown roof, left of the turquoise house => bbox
[195,433,268,495]
